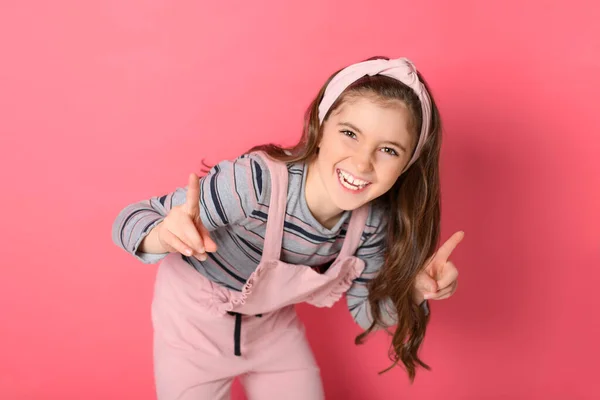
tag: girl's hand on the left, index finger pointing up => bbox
[156,173,217,261]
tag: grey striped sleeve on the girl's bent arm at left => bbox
[112,154,270,264]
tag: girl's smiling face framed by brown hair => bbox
[307,96,417,217]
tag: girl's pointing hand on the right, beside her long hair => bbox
[414,231,465,304]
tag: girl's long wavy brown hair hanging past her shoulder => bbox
[249,57,441,382]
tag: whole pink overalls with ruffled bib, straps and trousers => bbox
[152,153,368,400]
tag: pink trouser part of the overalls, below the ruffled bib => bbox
[152,254,324,400]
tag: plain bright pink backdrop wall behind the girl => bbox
[0,0,600,400]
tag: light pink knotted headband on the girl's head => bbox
[319,58,431,171]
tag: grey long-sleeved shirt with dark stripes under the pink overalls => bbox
[112,153,395,329]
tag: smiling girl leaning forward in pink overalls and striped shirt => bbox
[113,57,463,400]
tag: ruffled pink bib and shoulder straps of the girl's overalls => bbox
[215,155,369,315]
